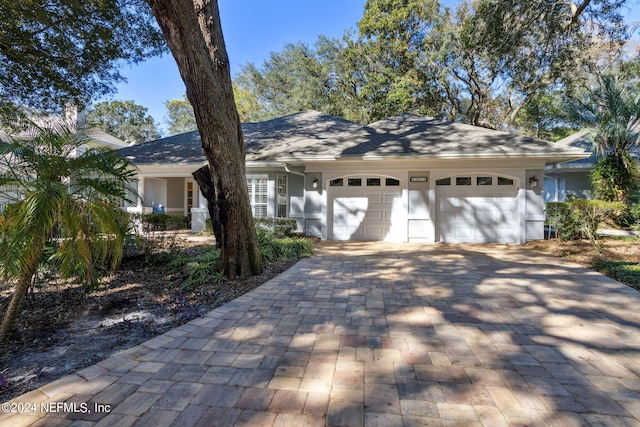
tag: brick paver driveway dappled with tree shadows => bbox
[0,242,640,427]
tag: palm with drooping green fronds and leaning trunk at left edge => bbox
[0,119,134,344]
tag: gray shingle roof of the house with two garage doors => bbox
[120,111,583,165]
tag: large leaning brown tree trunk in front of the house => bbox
[147,0,262,278]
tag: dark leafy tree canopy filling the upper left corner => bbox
[0,0,165,112]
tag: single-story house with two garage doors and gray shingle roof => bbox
[121,111,589,243]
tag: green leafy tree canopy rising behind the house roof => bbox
[236,0,629,132]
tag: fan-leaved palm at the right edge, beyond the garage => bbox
[572,75,640,203]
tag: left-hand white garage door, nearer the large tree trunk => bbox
[329,176,406,241]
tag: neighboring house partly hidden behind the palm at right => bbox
[544,130,640,202]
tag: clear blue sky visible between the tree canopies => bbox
[109,0,640,134]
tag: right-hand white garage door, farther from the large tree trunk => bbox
[436,176,519,243]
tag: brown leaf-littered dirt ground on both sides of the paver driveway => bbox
[0,234,640,401]
